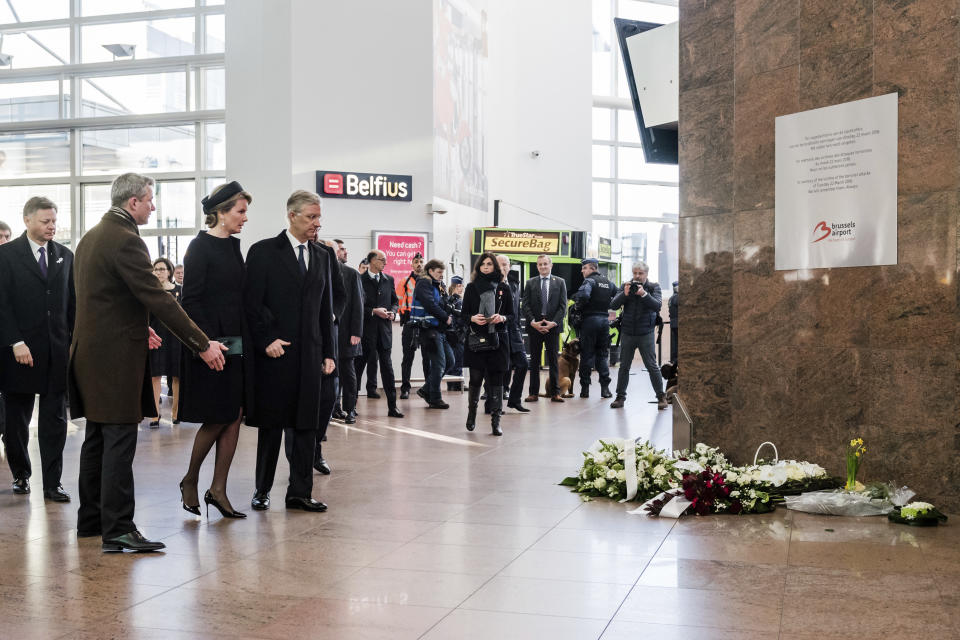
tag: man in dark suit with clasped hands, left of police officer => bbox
[520,255,567,402]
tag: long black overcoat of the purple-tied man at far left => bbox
[0,233,76,394]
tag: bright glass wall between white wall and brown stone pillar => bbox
[592,0,680,290]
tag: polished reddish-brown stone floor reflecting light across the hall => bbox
[0,377,960,640]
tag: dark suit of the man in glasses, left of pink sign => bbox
[357,271,400,407]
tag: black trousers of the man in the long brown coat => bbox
[77,420,137,540]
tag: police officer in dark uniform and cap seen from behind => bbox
[573,258,616,398]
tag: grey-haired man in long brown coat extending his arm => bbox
[69,173,226,551]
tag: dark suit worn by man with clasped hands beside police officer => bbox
[520,275,567,396]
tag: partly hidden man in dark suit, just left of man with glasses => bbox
[333,240,363,424]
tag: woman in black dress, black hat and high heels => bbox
[180,182,253,518]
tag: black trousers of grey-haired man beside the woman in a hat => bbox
[256,427,317,498]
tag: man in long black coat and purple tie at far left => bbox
[0,196,76,502]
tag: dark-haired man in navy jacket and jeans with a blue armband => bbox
[410,260,453,409]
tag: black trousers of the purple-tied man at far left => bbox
[3,391,67,489]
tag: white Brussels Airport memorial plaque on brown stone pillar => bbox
[774,93,897,270]
